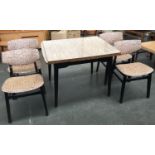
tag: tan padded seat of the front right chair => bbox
[116,62,153,77]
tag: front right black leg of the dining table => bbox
[107,57,113,96]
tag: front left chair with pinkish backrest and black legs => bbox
[2,49,48,123]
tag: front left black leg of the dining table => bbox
[54,64,59,107]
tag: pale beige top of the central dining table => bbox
[41,36,120,64]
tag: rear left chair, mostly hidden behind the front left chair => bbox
[8,38,41,76]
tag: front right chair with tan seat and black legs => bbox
[113,40,153,103]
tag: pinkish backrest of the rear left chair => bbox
[8,38,39,50]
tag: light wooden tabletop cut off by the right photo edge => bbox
[142,41,155,54]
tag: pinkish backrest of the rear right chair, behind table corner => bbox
[99,32,123,45]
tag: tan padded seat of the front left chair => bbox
[2,74,44,93]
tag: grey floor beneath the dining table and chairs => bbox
[0,50,155,125]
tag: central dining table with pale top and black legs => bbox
[41,36,120,107]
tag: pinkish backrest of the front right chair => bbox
[114,40,141,54]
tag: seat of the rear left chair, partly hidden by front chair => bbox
[8,61,41,74]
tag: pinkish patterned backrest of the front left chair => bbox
[2,49,39,65]
